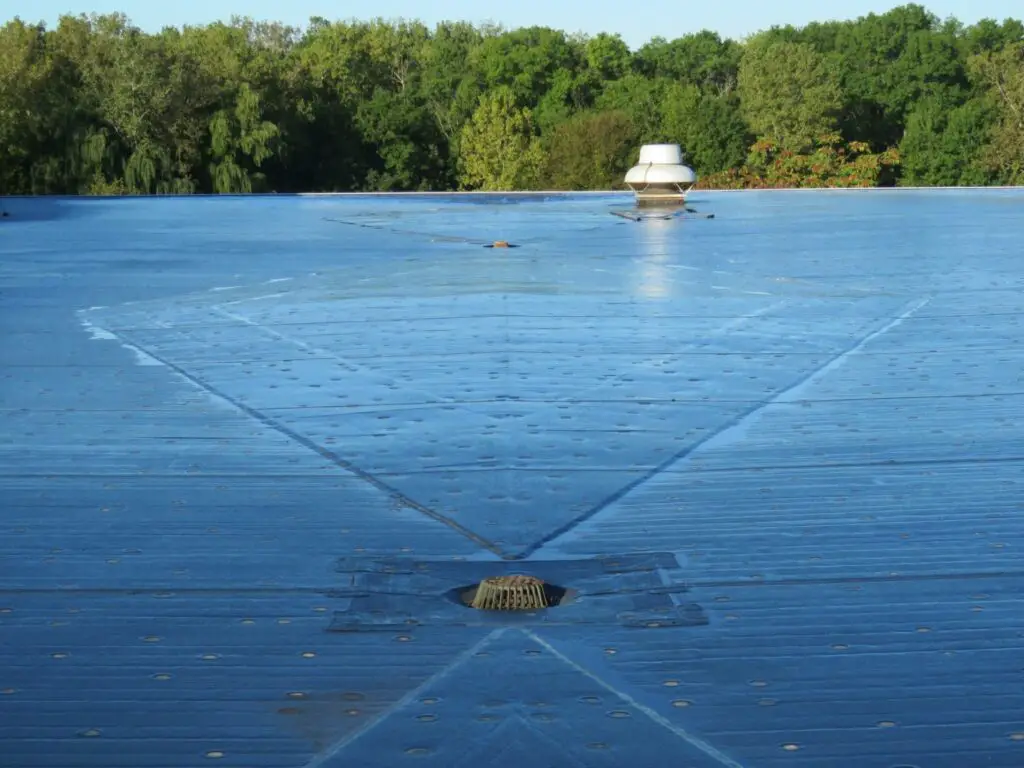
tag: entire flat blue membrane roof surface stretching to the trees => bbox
[0,190,1024,768]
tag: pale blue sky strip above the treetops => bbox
[14,0,1024,48]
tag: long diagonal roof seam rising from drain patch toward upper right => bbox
[513,297,931,560]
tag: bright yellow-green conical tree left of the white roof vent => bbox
[459,87,544,191]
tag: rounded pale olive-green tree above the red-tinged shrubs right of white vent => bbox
[739,39,843,152]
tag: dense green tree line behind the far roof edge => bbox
[0,4,1024,195]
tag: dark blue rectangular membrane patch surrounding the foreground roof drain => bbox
[326,552,709,640]
